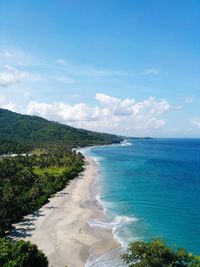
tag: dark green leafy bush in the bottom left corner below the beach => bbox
[0,238,48,267]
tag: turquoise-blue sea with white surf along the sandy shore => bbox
[84,138,200,267]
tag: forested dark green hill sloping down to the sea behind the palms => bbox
[0,109,121,151]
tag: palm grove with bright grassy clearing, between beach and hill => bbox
[0,146,83,236]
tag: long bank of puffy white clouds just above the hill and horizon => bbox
[0,93,171,135]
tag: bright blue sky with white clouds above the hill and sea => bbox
[0,0,200,137]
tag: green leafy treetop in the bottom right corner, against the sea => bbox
[122,239,200,267]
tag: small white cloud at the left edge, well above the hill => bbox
[0,65,29,87]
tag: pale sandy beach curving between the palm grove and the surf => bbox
[9,157,119,267]
